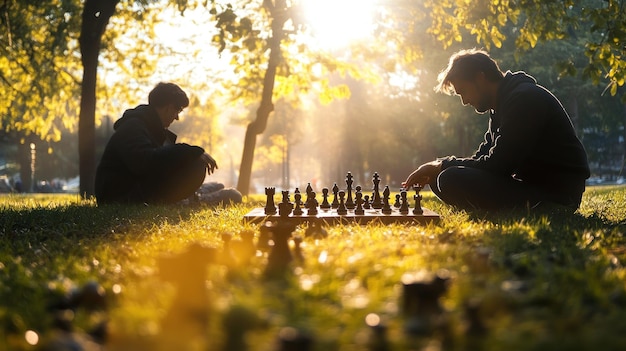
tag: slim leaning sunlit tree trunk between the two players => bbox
[237,0,286,196]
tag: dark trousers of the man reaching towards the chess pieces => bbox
[430,166,584,210]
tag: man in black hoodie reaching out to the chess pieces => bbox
[403,49,589,211]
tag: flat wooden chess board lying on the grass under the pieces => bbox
[243,207,440,224]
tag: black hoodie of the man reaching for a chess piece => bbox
[442,72,590,202]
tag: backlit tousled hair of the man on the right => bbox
[435,49,504,95]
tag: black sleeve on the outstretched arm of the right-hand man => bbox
[442,90,545,175]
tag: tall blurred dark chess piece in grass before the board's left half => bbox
[265,221,296,278]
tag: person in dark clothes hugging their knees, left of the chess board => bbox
[95,83,241,204]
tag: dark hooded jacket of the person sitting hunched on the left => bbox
[95,105,204,203]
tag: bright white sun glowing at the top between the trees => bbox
[301,0,376,50]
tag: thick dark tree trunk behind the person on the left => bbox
[78,0,119,199]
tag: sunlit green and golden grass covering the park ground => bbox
[0,187,626,350]
